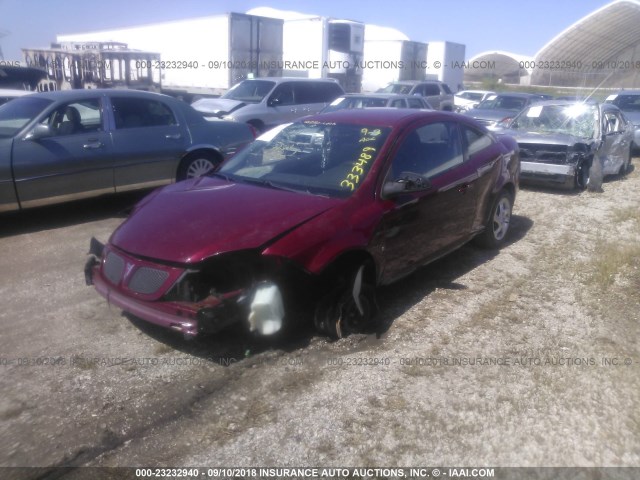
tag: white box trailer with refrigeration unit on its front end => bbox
[247,7,365,92]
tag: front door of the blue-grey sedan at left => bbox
[12,95,114,207]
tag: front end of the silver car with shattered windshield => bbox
[518,142,594,188]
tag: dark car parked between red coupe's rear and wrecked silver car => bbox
[464,93,540,130]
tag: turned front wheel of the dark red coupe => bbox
[314,268,378,339]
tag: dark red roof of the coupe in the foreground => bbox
[301,108,458,127]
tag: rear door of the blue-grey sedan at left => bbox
[110,94,190,191]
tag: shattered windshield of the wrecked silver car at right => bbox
[511,103,598,138]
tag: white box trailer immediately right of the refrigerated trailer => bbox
[362,25,427,92]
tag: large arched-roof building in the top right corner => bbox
[531,0,640,88]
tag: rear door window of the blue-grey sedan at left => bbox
[111,97,178,130]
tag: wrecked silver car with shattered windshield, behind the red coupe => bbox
[505,100,633,189]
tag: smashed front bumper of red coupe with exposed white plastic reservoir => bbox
[85,239,310,337]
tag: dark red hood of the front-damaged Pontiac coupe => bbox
[110,177,344,264]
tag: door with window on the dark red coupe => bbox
[376,121,477,283]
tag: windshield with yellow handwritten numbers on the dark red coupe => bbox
[218,121,390,197]
